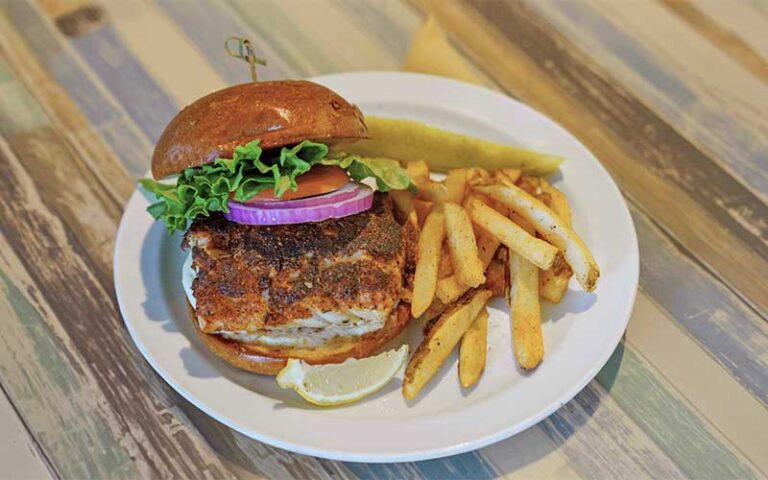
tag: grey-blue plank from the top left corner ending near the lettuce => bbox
[0,1,152,178]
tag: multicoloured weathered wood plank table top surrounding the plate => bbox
[0,0,768,479]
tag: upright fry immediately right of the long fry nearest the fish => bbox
[445,202,485,287]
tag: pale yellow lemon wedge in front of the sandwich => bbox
[277,345,408,406]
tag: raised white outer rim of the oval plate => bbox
[113,71,639,463]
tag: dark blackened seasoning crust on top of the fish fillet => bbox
[184,193,405,332]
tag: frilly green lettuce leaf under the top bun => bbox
[140,140,414,233]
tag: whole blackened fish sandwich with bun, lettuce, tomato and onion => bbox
[142,81,416,375]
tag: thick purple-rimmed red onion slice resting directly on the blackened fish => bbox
[224,185,373,225]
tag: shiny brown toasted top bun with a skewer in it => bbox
[152,80,368,179]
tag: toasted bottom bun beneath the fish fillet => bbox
[187,302,411,375]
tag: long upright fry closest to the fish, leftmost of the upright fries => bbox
[411,205,445,317]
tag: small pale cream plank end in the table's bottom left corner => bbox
[0,388,57,480]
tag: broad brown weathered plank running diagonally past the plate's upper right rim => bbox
[414,2,768,318]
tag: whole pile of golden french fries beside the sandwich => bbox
[392,161,600,400]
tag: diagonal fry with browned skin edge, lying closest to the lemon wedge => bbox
[403,289,491,400]
